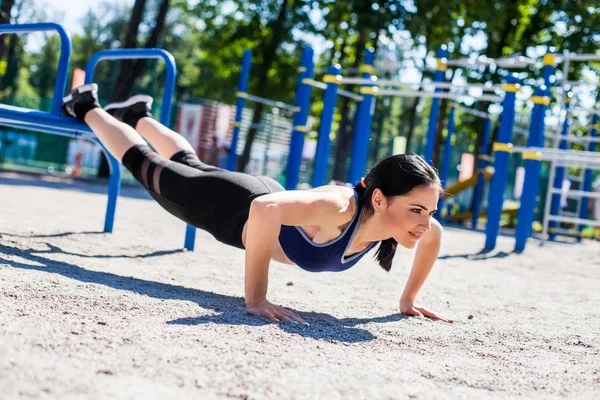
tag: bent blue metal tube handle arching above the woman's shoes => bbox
[85,49,177,126]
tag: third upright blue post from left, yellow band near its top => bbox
[312,64,341,187]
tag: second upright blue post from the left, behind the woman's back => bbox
[285,47,314,190]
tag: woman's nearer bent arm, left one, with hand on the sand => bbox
[245,191,352,322]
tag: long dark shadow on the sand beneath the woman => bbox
[0,239,420,343]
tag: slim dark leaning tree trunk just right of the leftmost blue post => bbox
[232,0,289,171]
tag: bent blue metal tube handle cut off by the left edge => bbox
[0,22,71,115]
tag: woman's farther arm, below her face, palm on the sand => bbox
[400,219,452,322]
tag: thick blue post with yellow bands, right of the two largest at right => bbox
[515,86,550,252]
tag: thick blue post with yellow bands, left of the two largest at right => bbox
[485,74,520,250]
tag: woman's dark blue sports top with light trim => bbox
[279,192,379,272]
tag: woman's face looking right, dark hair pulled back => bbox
[373,185,440,249]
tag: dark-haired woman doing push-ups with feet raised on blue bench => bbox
[63,84,452,323]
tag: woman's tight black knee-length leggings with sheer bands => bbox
[123,145,285,249]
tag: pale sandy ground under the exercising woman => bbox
[0,172,600,399]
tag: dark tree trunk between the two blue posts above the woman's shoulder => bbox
[332,29,367,182]
